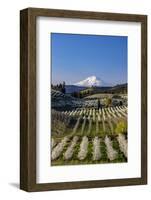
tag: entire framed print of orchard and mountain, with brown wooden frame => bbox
[20,8,147,191]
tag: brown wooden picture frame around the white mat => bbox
[20,8,147,192]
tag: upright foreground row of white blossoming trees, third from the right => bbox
[93,137,101,160]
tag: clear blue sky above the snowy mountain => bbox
[50,33,127,85]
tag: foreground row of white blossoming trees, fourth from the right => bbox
[78,136,89,160]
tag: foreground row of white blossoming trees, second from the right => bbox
[104,136,117,161]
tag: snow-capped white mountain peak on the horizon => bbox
[74,76,108,87]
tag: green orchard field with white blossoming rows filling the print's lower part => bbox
[51,106,127,166]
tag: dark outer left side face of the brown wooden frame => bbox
[20,9,29,191]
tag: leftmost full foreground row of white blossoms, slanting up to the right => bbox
[51,137,68,160]
